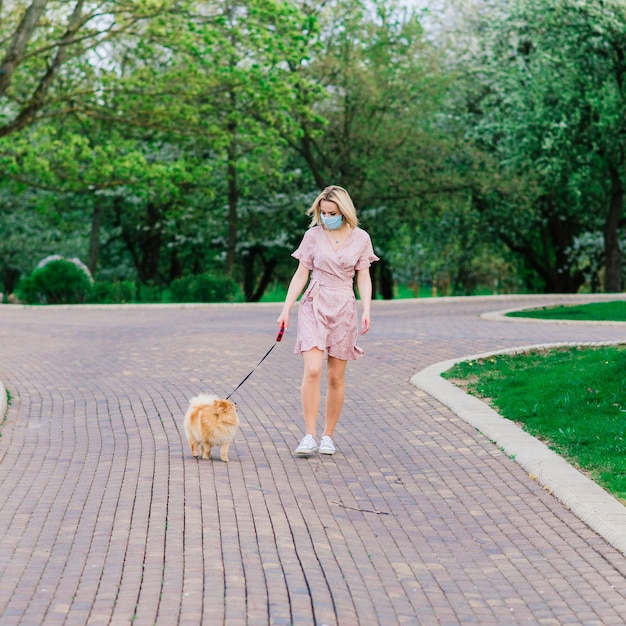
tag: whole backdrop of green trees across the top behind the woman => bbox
[0,0,626,301]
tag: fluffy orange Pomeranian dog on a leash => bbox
[185,394,239,461]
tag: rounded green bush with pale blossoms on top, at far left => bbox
[17,259,91,304]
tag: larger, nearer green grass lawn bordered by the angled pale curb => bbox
[445,346,626,501]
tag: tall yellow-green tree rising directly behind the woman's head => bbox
[260,0,461,297]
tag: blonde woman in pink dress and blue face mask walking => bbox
[277,185,378,456]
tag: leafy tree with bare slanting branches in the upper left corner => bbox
[0,0,194,288]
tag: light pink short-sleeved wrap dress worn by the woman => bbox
[292,226,378,361]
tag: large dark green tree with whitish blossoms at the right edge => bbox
[446,0,626,292]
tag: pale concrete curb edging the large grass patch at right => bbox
[411,342,626,555]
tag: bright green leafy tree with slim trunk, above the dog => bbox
[95,0,320,288]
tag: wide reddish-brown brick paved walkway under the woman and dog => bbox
[0,297,626,626]
